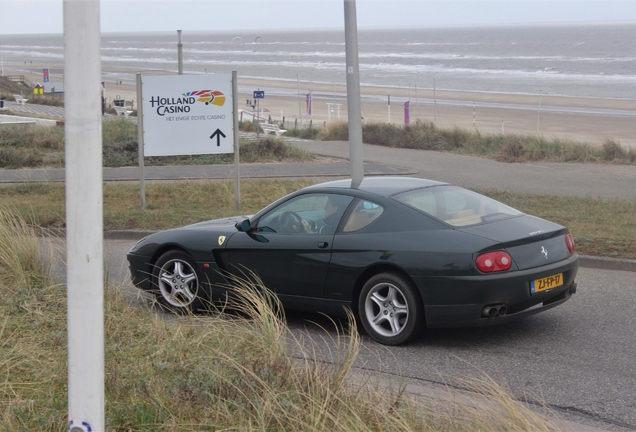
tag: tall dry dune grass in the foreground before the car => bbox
[0,208,554,432]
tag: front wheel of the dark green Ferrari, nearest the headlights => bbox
[152,250,203,312]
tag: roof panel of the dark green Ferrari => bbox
[303,177,448,196]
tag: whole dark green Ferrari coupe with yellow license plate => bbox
[128,177,578,345]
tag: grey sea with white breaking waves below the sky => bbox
[0,22,636,99]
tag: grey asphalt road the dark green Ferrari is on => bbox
[104,240,636,431]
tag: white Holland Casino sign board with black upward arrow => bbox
[141,74,234,156]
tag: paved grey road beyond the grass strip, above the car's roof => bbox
[289,139,636,199]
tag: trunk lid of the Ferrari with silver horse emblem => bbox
[460,215,570,270]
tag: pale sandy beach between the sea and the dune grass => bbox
[5,64,636,148]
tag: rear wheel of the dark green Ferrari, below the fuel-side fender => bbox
[358,273,424,345]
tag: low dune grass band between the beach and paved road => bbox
[0,117,636,169]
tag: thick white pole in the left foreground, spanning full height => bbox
[64,0,104,432]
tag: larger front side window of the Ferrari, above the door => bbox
[256,193,353,234]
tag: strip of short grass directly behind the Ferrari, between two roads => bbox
[0,179,636,259]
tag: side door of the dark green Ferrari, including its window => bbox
[227,193,353,298]
